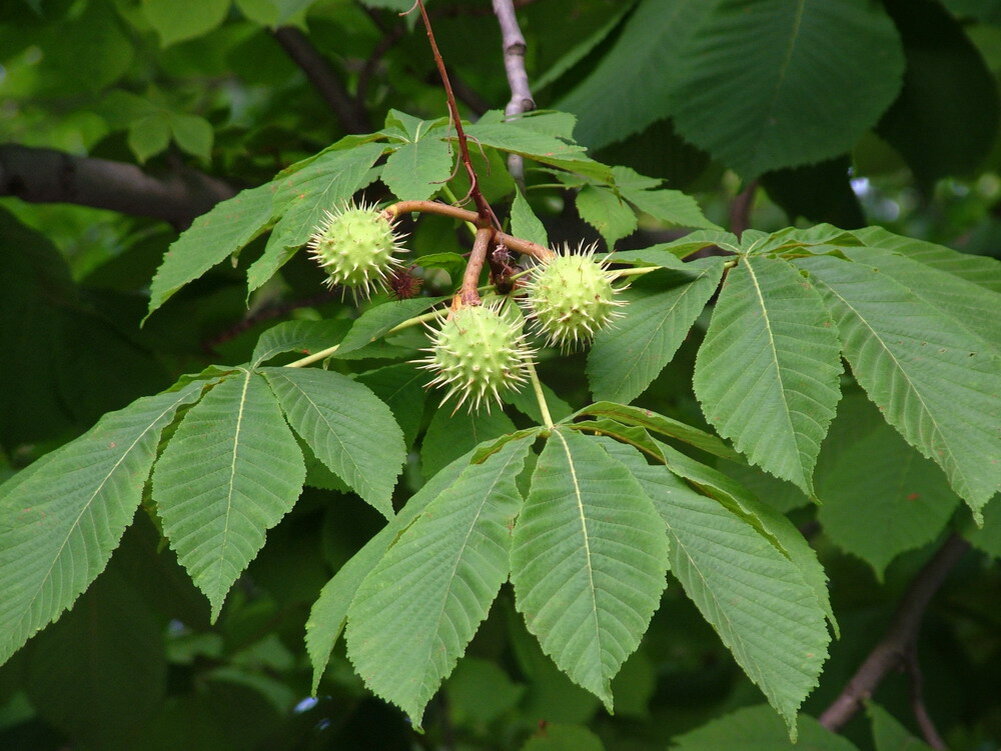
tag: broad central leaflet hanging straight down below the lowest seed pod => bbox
[511,429,668,710]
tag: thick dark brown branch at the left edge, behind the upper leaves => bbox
[0,143,236,229]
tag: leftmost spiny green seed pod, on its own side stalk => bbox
[307,203,402,298]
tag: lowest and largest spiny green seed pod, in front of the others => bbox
[417,305,535,412]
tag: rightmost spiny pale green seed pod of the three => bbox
[524,245,625,350]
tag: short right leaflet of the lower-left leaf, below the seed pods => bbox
[260,367,406,519]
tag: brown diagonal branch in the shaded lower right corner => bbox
[820,534,970,731]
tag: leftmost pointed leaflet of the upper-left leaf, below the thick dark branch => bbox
[147,183,274,317]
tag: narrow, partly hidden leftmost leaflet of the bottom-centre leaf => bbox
[306,452,472,695]
